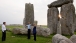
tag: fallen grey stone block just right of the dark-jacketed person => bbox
[31,27,50,37]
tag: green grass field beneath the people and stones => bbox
[0,26,75,43]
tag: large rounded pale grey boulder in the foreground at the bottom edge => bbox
[52,34,73,43]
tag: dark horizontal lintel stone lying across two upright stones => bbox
[48,0,73,8]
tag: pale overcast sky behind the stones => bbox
[0,0,76,25]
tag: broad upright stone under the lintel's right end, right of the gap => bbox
[61,3,75,35]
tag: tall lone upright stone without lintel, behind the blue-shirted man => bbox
[23,3,34,27]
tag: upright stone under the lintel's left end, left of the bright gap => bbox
[47,7,59,34]
